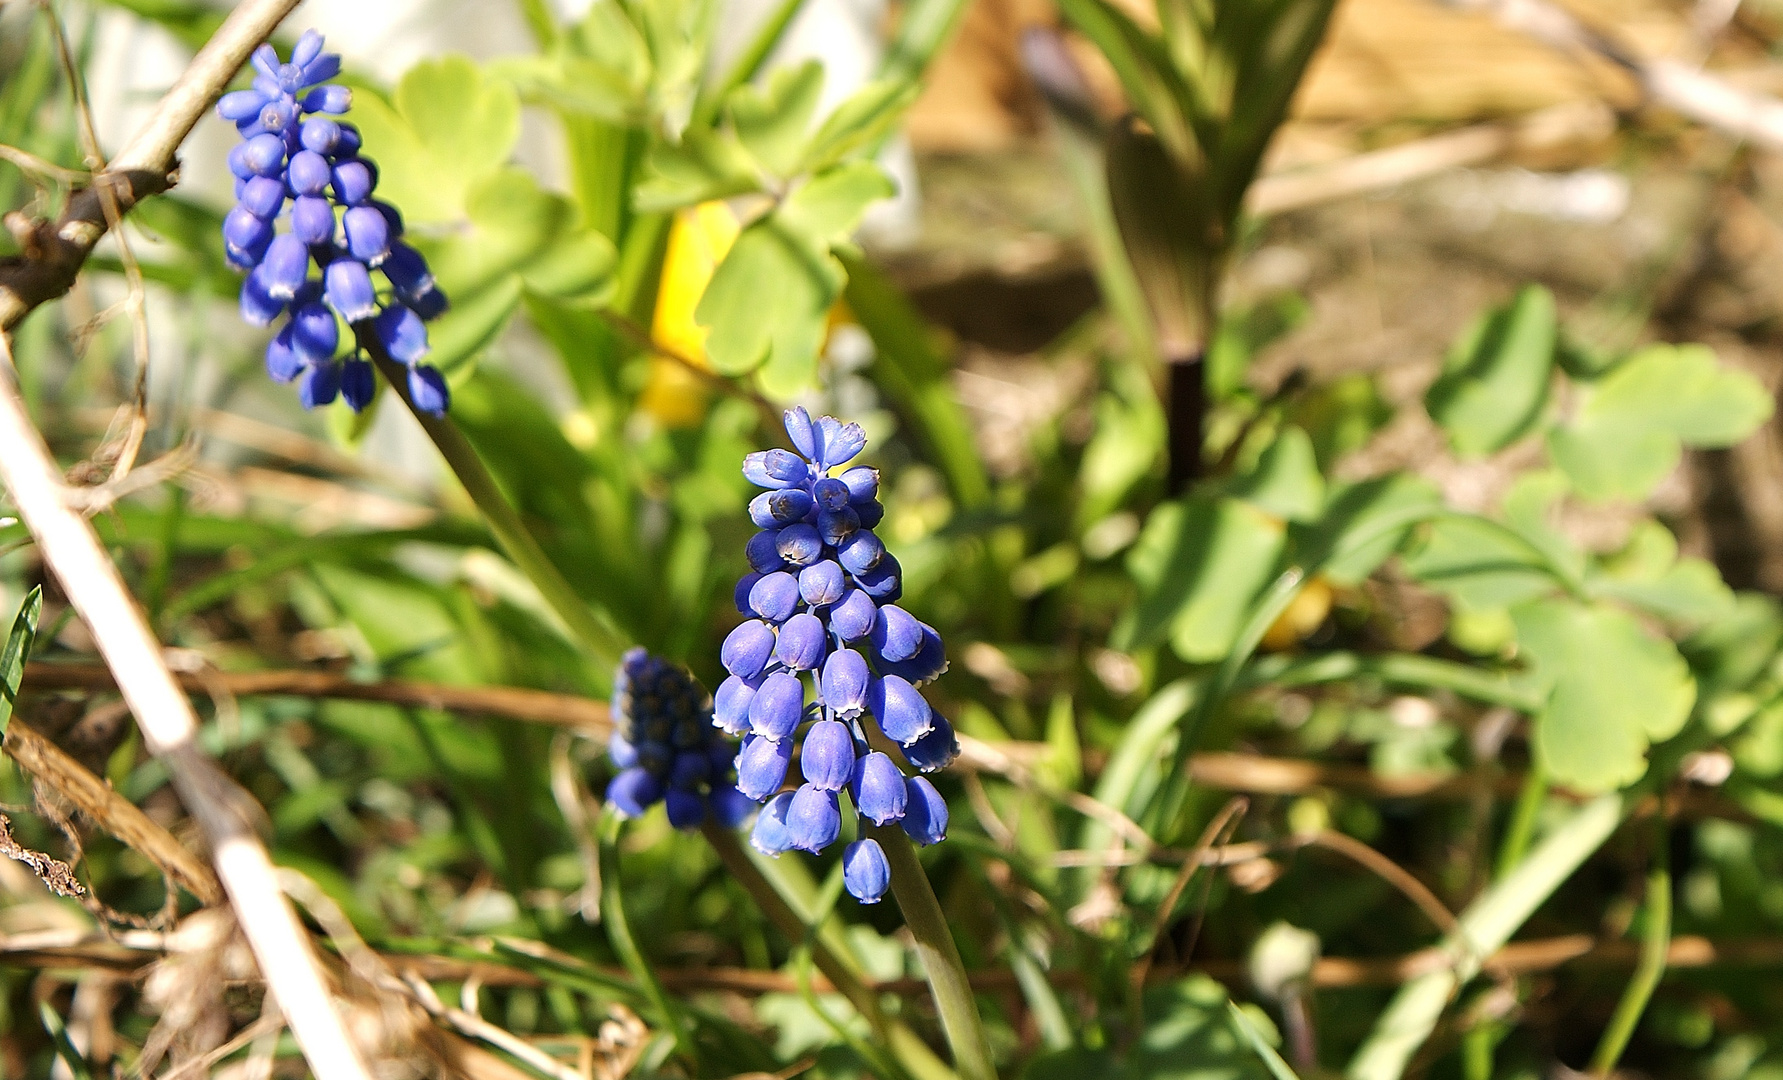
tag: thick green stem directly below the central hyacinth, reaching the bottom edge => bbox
[861,820,997,1080]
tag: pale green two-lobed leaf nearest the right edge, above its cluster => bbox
[1548,346,1772,499]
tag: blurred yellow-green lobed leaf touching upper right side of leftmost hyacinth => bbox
[349,55,521,223]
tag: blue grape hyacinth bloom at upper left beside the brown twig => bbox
[218,30,449,415]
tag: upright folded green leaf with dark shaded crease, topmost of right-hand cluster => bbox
[1425,285,1557,456]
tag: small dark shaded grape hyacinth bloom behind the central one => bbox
[606,649,754,829]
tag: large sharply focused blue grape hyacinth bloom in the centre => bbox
[711,408,959,904]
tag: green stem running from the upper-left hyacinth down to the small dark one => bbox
[358,352,626,677]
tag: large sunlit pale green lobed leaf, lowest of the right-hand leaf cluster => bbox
[1510,599,1696,793]
